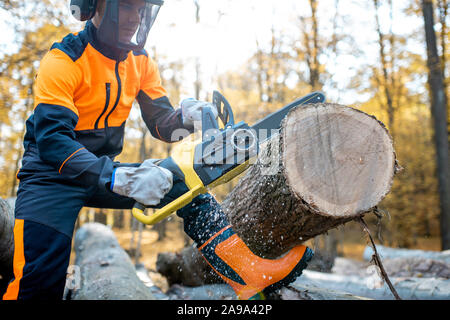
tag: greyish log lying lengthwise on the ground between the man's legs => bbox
[68,223,154,300]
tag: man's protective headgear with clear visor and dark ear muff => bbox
[70,0,164,50]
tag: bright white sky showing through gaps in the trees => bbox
[0,0,425,103]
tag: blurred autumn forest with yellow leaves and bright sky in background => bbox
[0,0,450,258]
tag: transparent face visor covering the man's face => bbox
[118,0,162,49]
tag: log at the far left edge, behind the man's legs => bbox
[0,199,14,293]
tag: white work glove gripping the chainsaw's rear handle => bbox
[111,160,173,206]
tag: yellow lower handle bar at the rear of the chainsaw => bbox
[131,186,205,225]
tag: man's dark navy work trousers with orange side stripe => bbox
[3,159,223,300]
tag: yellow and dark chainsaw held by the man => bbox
[132,91,325,225]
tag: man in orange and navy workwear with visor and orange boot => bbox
[3,0,313,299]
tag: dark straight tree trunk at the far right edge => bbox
[422,0,450,250]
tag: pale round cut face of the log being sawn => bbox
[282,103,395,217]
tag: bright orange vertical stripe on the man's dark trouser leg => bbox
[3,219,25,300]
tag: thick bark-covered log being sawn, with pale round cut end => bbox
[223,104,399,258]
